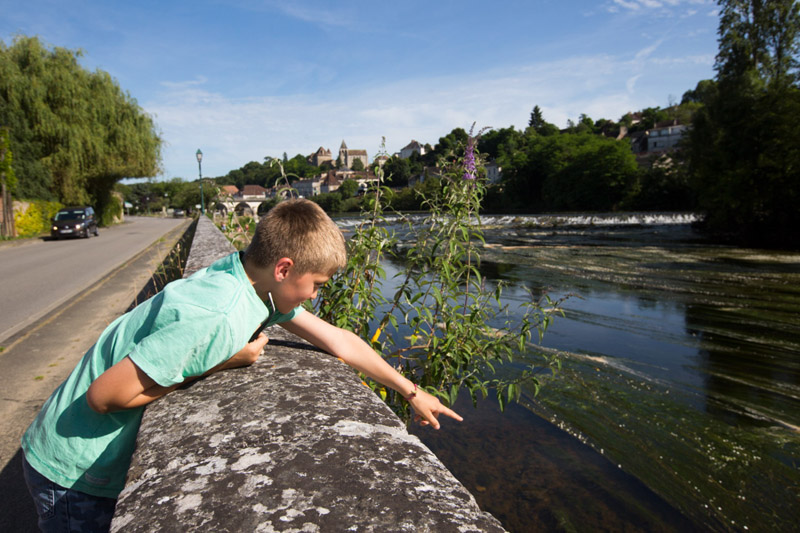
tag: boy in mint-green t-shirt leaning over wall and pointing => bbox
[22,200,461,531]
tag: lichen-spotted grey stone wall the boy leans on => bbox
[111,217,503,532]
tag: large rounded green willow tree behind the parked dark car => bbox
[0,37,162,220]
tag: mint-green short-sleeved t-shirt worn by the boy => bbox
[22,253,301,498]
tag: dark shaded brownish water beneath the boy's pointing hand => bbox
[412,395,696,533]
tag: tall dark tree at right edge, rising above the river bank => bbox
[687,0,800,247]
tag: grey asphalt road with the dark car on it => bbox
[0,217,183,346]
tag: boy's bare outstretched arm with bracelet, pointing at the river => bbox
[281,313,463,429]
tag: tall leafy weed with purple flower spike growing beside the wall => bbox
[316,131,561,421]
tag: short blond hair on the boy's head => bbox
[245,199,347,276]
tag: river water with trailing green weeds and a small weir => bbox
[340,214,800,532]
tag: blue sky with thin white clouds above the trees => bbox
[0,0,719,180]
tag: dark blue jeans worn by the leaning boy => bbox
[22,458,117,533]
